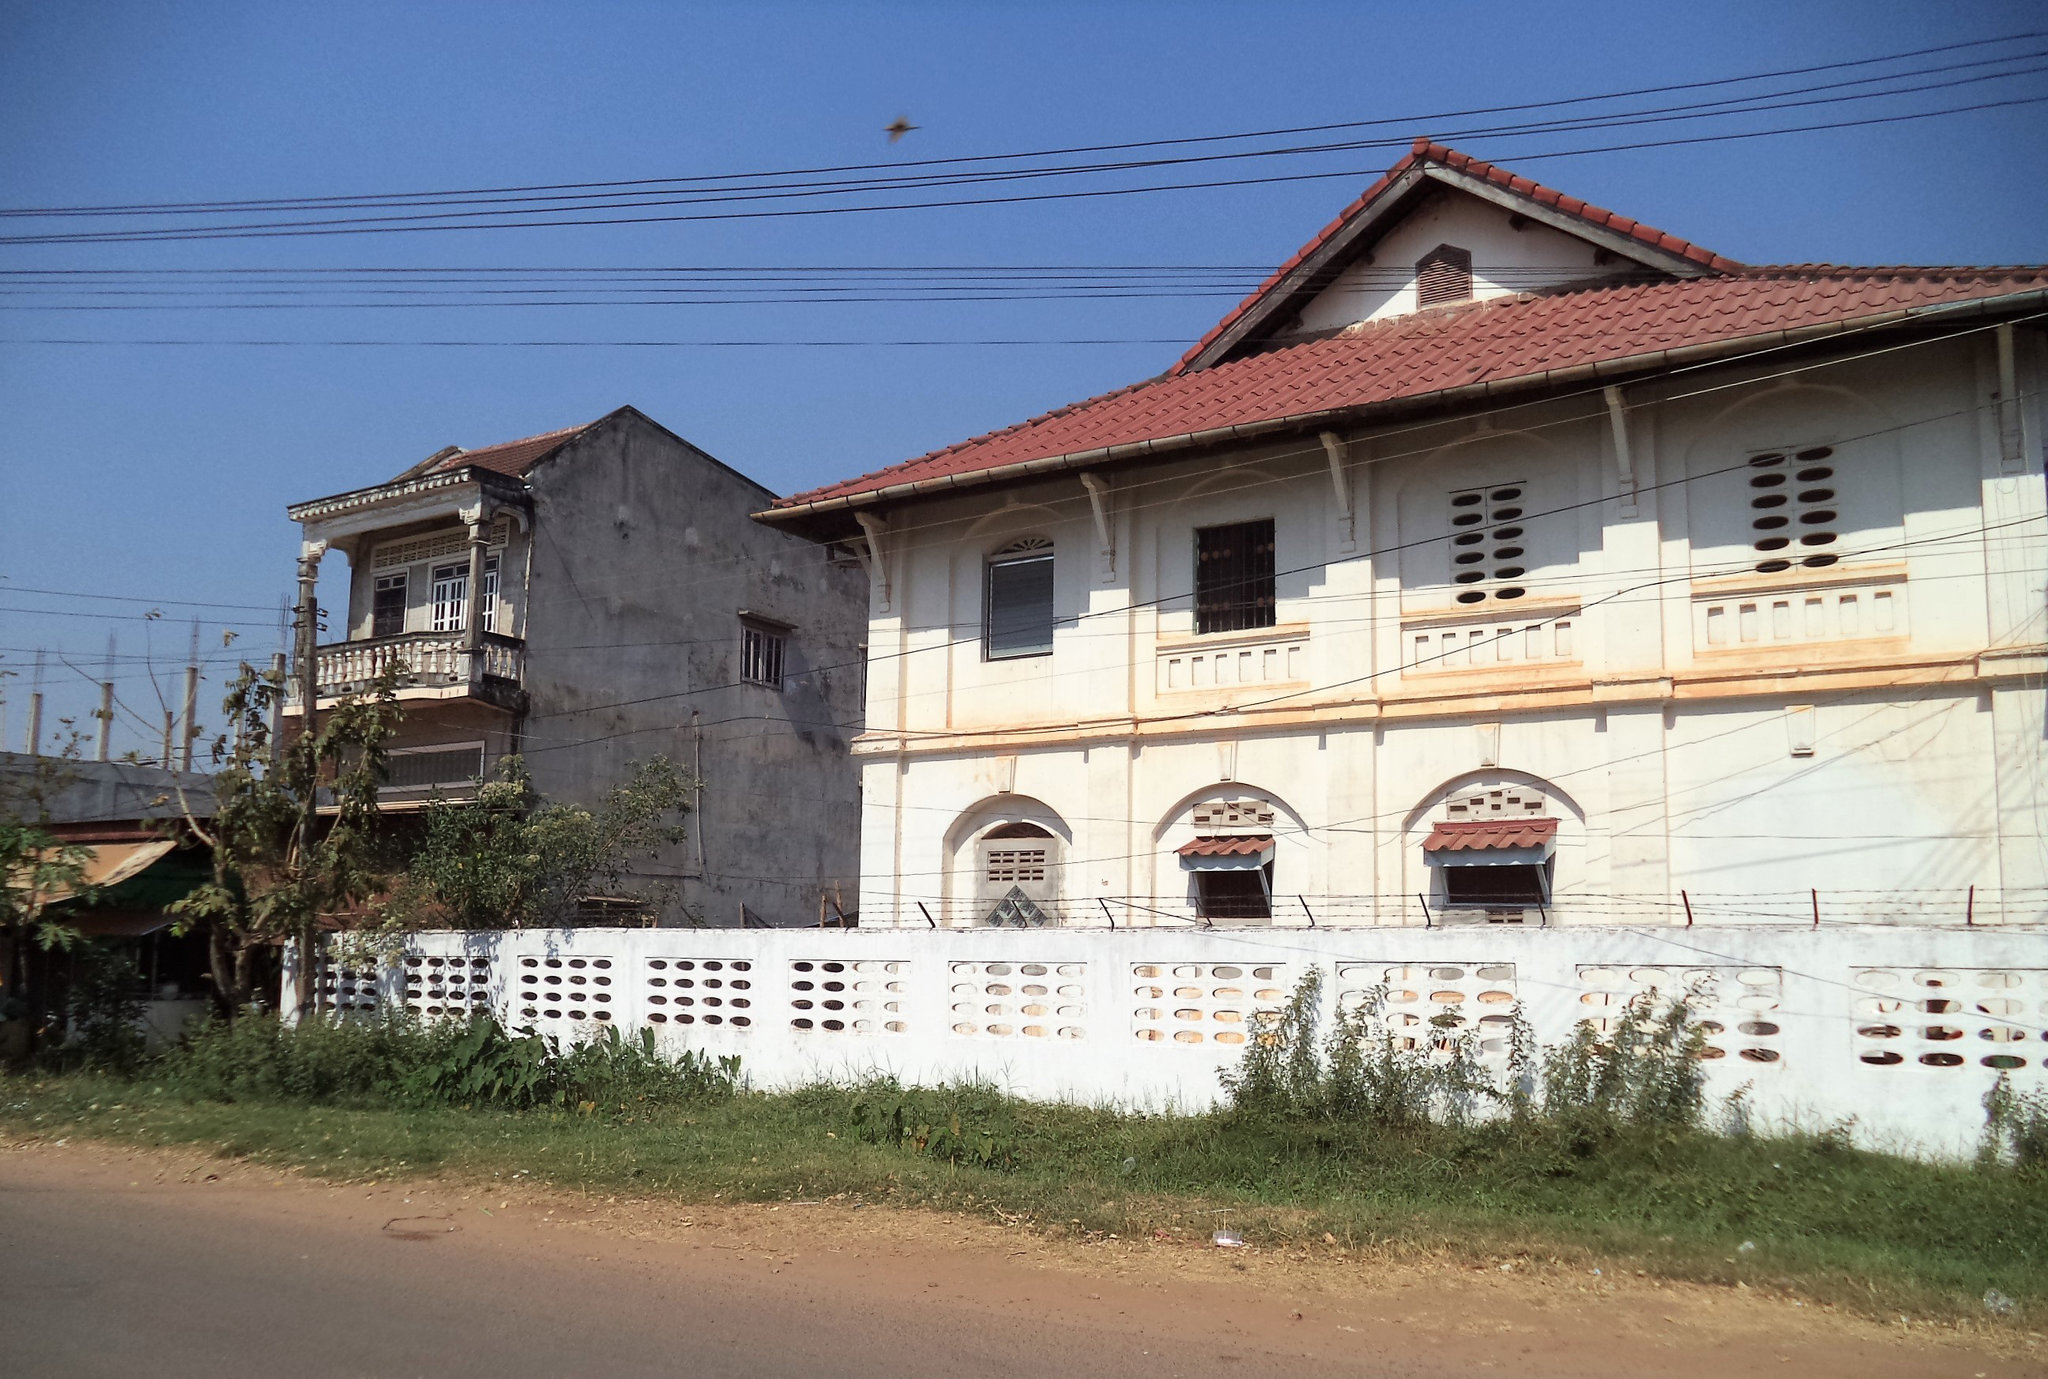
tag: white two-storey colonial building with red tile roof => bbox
[762,141,2048,930]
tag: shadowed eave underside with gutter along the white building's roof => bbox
[754,289,2048,541]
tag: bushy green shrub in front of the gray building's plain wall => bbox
[383,756,690,930]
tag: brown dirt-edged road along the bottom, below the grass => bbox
[0,1141,2048,1379]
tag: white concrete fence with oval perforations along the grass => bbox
[292,926,2048,1156]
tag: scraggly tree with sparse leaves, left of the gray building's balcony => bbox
[172,662,399,1014]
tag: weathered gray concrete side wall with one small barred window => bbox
[518,414,866,926]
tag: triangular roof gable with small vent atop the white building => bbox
[1169,139,1741,375]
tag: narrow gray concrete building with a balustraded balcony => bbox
[289,408,866,926]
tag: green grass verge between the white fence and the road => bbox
[0,1074,2048,1326]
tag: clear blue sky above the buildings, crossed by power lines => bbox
[0,0,2048,750]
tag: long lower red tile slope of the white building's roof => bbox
[776,264,2048,508]
